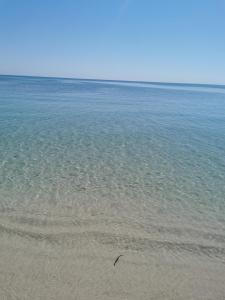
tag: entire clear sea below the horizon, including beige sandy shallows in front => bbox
[0,76,225,299]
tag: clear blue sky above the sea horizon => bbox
[0,0,225,84]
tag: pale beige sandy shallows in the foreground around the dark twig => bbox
[0,213,225,300]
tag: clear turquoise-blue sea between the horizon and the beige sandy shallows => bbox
[0,76,225,230]
